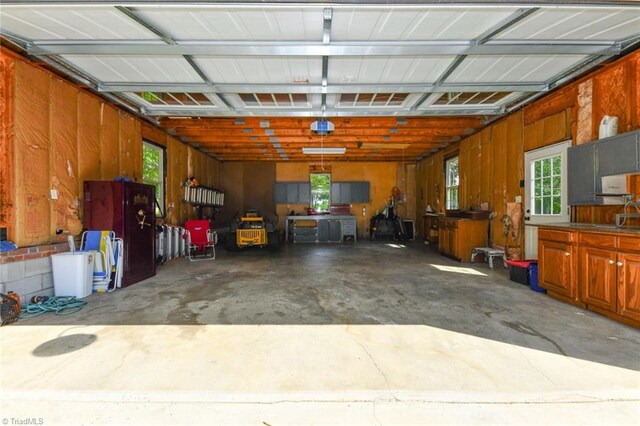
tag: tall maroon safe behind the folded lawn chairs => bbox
[83,181,156,287]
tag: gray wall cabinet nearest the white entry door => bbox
[567,143,602,206]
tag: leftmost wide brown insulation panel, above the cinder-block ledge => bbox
[14,61,51,245]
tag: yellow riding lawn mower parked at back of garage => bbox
[227,210,280,251]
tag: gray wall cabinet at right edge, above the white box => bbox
[597,131,640,176]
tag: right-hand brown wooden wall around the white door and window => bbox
[416,52,640,256]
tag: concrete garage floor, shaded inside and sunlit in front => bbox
[0,242,640,426]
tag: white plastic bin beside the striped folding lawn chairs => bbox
[51,252,95,299]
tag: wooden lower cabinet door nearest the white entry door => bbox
[538,240,577,300]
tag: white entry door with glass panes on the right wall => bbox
[524,141,571,259]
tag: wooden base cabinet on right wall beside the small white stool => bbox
[438,217,489,262]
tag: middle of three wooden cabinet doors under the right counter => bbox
[579,247,617,312]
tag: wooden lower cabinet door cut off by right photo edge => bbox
[617,253,640,321]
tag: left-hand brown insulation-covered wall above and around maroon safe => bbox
[0,51,219,246]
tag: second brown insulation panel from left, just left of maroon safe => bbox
[49,78,82,234]
